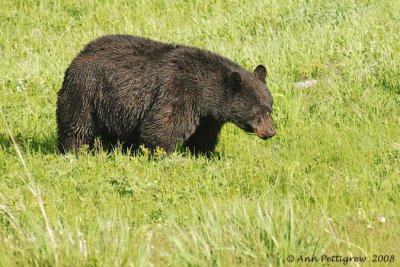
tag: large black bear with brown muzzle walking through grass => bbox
[56,35,275,154]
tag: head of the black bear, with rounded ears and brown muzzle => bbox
[226,65,275,139]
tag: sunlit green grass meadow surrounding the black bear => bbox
[0,0,400,266]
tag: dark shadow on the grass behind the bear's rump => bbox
[0,132,59,155]
